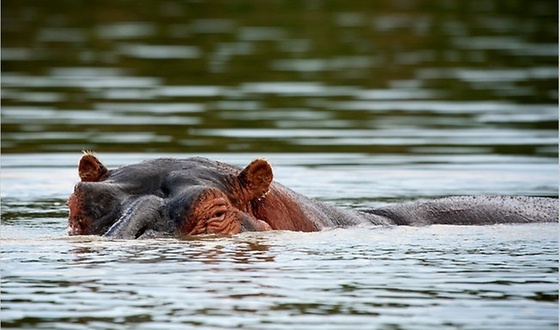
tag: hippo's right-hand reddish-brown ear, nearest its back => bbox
[238,159,273,200]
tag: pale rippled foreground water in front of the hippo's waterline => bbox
[2,219,558,329]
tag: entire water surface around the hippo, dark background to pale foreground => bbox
[0,0,559,330]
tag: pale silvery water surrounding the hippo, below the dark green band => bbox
[0,153,558,329]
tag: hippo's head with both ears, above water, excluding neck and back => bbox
[67,153,273,238]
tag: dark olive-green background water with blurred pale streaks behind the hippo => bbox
[2,1,558,157]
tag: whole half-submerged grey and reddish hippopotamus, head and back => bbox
[67,153,558,239]
